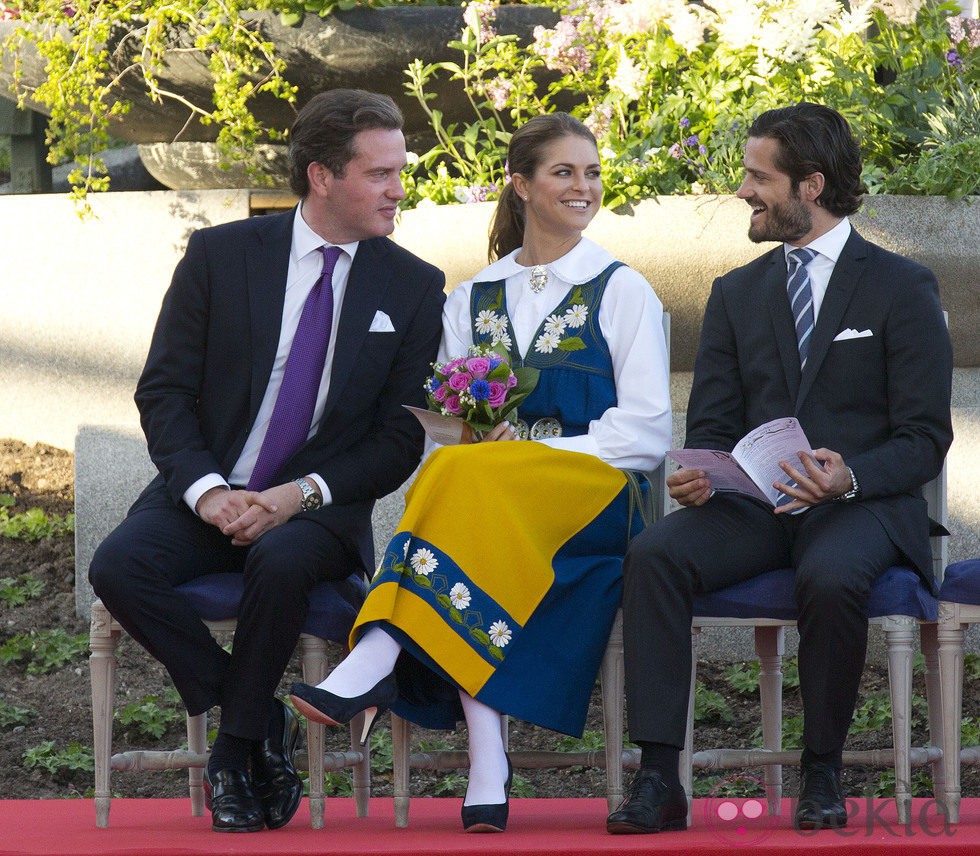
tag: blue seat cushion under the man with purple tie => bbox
[177,573,367,642]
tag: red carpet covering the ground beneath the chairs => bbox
[0,798,980,856]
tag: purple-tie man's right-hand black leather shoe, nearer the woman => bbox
[252,699,303,829]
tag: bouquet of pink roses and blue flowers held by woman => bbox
[425,345,540,437]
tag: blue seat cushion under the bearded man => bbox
[694,567,936,621]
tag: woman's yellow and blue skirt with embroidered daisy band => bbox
[351,442,642,735]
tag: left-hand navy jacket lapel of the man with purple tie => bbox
[245,209,295,425]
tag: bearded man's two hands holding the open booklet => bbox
[667,449,852,514]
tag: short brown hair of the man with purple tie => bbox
[289,89,404,198]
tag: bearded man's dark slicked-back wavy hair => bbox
[749,101,864,217]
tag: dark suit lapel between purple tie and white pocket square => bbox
[320,238,391,428]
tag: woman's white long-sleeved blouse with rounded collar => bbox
[439,238,671,472]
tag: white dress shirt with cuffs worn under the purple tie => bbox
[184,204,358,511]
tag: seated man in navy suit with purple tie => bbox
[90,90,445,832]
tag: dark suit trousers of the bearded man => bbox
[623,493,901,754]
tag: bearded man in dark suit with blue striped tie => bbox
[607,102,952,833]
